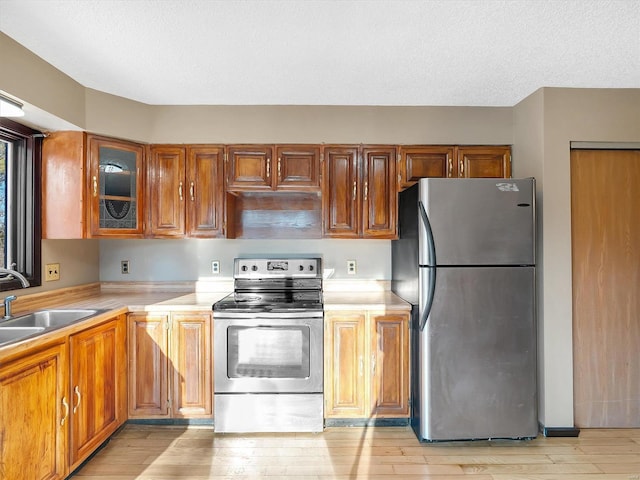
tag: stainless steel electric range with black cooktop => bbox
[213,257,324,432]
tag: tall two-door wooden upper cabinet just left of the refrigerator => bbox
[322,146,397,238]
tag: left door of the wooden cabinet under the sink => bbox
[0,344,69,480]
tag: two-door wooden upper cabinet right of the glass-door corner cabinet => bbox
[148,145,224,238]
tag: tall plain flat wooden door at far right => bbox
[571,150,640,428]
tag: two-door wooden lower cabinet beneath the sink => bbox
[0,315,127,480]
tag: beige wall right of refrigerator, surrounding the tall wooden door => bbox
[513,88,640,427]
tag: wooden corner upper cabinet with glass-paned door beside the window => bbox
[42,131,145,238]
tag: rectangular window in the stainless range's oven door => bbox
[227,325,310,378]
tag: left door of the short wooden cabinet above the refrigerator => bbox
[398,146,457,190]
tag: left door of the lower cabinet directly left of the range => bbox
[128,313,169,418]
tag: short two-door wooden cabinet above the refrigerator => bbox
[398,145,511,190]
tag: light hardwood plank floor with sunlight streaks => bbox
[74,425,640,480]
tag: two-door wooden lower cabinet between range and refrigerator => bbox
[324,311,409,418]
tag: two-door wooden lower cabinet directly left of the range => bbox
[128,312,213,418]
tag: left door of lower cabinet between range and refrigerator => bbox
[324,312,369,418]
